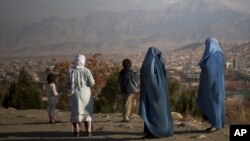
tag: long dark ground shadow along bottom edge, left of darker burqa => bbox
[0,131,145,141]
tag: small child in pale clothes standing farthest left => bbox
[46,73,58,123]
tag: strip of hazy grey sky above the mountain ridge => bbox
[0,0,250,21]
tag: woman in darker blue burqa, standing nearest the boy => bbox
[139,47,173,138]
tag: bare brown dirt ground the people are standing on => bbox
[0,108,229,141]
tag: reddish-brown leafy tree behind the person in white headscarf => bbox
[53,54,120,109]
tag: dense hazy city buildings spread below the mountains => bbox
[0,42,250,98]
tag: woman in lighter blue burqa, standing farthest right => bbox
[197,38,225,132]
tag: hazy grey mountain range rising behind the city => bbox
[0,0,250,57]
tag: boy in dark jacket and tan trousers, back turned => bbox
[119,59,138,122]
